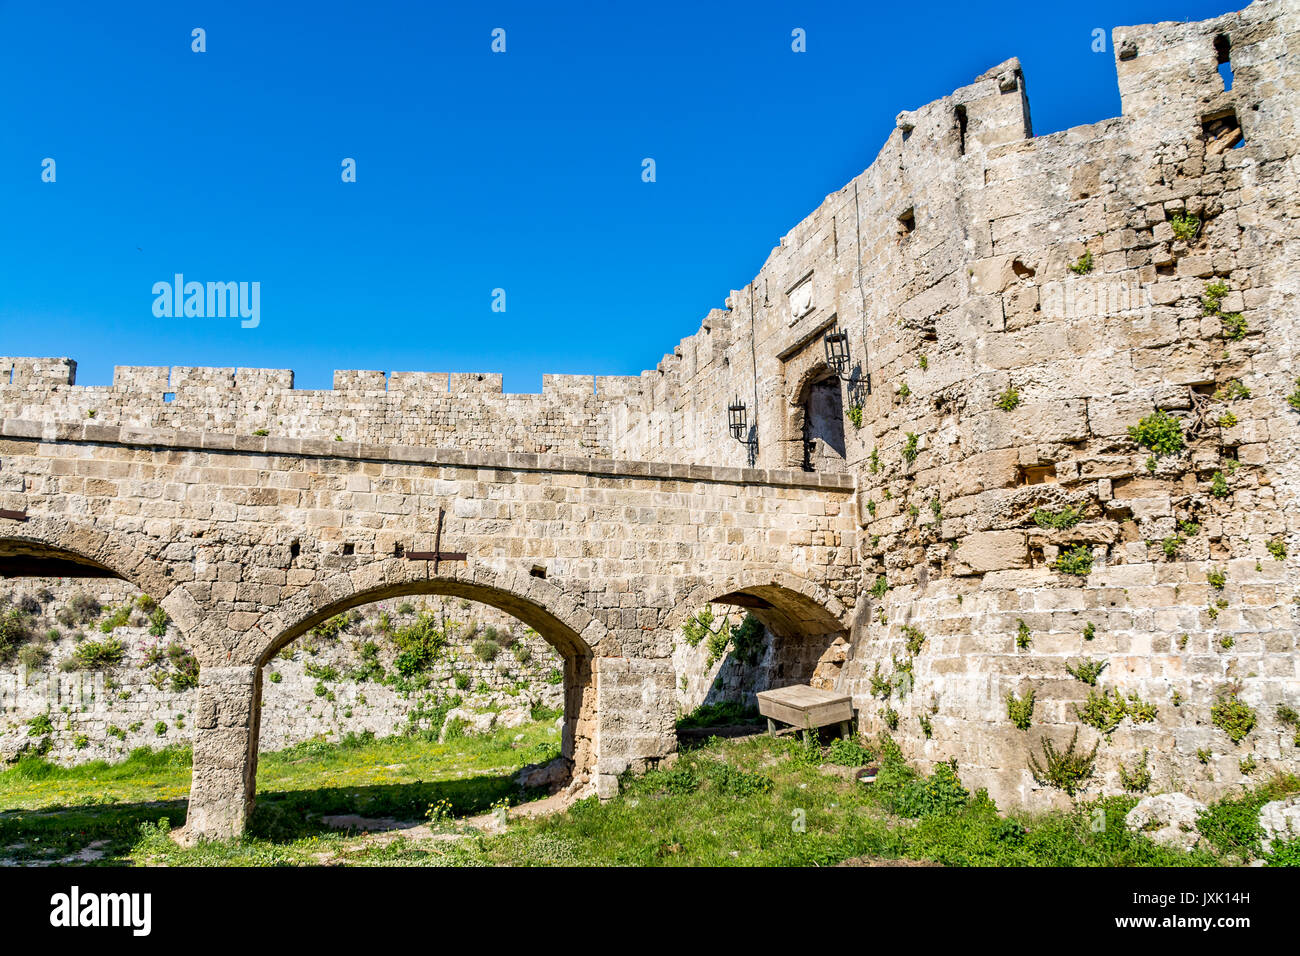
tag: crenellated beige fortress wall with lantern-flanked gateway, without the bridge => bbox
[0,0,1300,805]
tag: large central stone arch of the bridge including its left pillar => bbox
[186,558,606,840]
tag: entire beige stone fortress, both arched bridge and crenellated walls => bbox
[0,0,1300,835]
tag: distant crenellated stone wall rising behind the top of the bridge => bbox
[0,358,642,458]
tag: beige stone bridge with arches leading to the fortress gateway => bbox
[0,419,857,839]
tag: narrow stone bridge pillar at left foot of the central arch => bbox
[185,666,261,843]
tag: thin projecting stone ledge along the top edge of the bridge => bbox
[0,419,854,492]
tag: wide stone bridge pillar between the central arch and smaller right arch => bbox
[595,657,677,800]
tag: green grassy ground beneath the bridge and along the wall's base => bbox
[0,723,1300,866]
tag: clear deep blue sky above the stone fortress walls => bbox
[0,0,1245,392]
